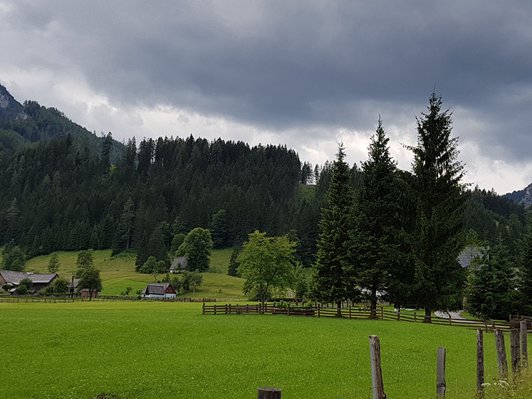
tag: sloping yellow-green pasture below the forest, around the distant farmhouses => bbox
[25,248,244,299]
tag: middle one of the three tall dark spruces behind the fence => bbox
[352,118,398,318]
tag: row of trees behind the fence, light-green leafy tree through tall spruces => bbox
[230,94,532,322]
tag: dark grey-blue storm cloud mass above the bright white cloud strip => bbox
[6,0,532,156]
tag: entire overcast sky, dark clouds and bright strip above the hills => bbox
[0,0,532,193]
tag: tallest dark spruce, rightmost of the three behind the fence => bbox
[409,93,464,323]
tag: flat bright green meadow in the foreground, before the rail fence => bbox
[0,302,512,399]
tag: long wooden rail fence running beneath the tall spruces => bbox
[202,303,510,331]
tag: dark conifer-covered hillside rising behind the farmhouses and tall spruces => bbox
[0,87,525,278]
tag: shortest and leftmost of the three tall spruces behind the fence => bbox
[313,145,357,316]
